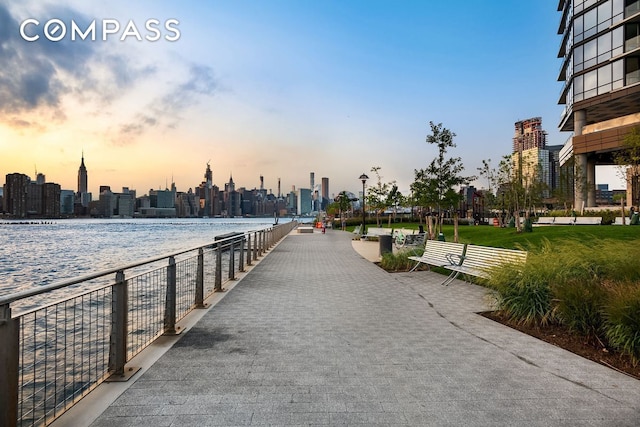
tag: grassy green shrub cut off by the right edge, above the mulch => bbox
[603,282,640,364]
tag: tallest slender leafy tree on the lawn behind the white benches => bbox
[411,122,475,241]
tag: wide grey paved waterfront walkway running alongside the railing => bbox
[93,230,640,427]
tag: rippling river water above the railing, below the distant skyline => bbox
[0,218,282,296]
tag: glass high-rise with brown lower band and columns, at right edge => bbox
[558,0,640,208]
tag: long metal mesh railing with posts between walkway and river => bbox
[0,221,297,426]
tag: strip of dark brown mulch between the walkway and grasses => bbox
[480,311,640,380]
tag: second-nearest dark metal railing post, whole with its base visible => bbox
[109,270,129,378]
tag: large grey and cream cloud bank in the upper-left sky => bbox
[0,0,219,145]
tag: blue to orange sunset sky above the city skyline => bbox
[0,0,624,196]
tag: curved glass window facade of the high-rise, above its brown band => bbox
[559,0,640,114]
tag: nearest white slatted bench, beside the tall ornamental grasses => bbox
[442,245,527,285]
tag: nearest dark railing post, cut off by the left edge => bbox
[0,304,20,427]
